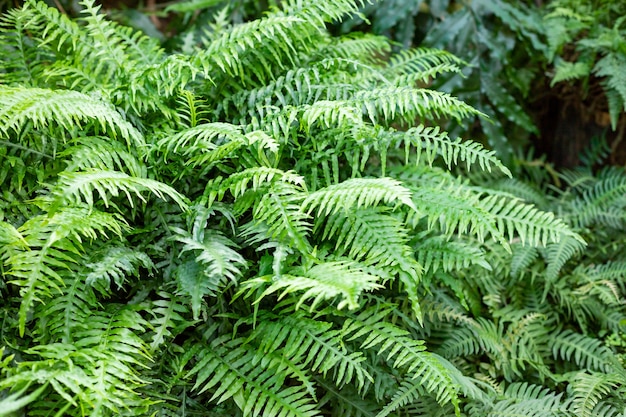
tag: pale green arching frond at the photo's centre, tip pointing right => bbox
[302,178,415,216]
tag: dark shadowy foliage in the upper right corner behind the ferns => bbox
[343,0,626,167]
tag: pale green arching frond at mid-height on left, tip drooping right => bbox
[50,169,187,210]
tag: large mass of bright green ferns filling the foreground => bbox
[0,0,626,417]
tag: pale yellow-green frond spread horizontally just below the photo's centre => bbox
[240,261,382,311]
